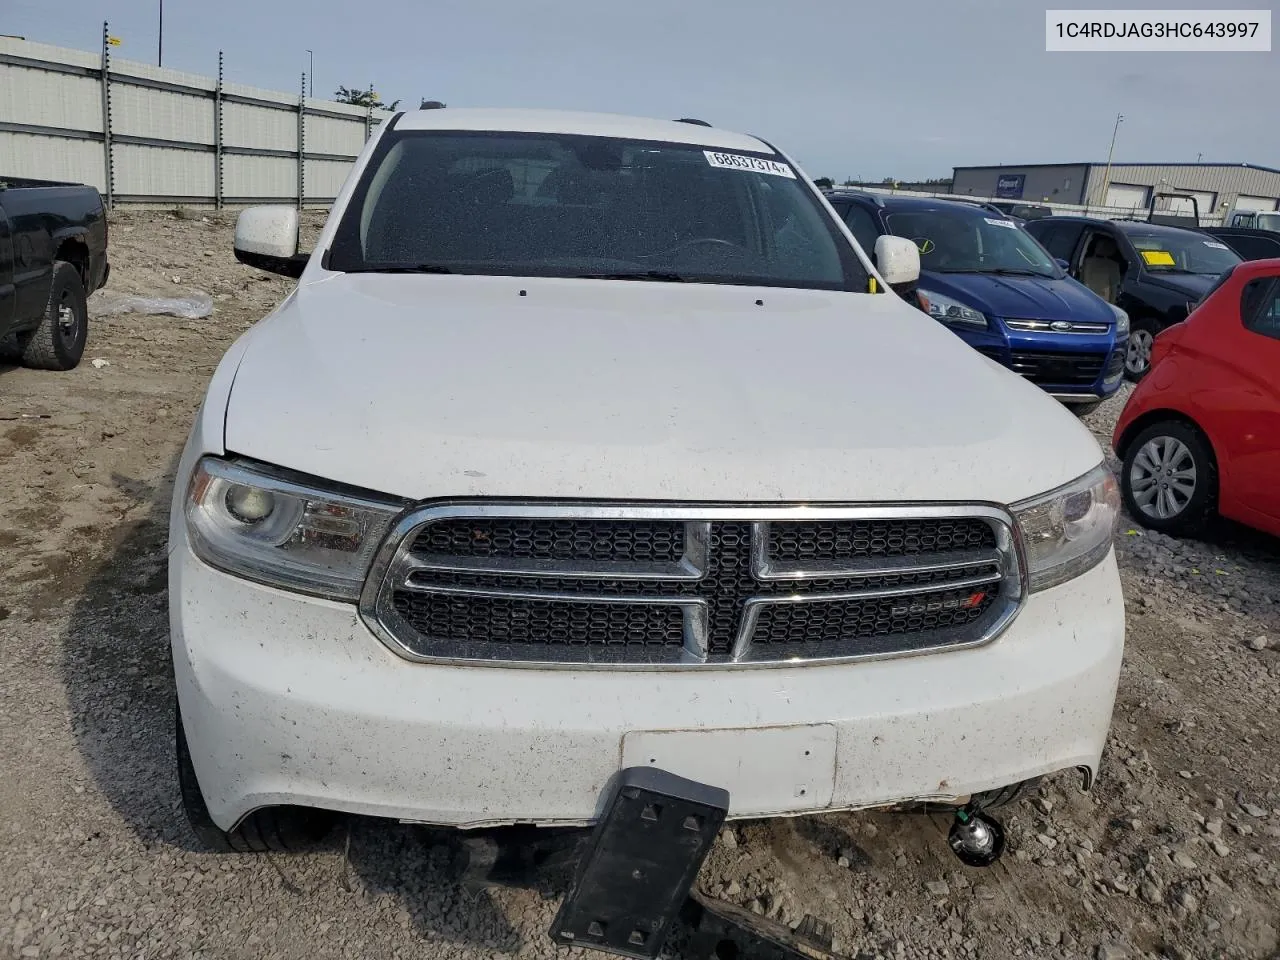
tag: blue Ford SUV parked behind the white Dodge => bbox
[827,191,1129,413]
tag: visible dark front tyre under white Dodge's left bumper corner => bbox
[174,708,334,854]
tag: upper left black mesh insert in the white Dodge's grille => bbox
[413,517,685,563]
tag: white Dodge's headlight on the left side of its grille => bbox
[186,457,403,600]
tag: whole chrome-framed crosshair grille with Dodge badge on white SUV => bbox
[361,503,1023,667]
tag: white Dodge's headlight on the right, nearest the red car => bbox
[1012,463,1120,591]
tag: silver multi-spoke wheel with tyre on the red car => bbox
[1120,420,1217,534]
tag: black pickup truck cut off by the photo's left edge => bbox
[0,177,110,370]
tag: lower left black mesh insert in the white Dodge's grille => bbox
[394,590,685,655]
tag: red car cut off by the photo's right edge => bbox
[1112,260,1280,536]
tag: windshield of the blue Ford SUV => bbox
[886,207,1061,276]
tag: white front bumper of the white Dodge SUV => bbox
[169,538,1124,829]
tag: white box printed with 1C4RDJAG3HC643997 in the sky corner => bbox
[1044,10,1271,52]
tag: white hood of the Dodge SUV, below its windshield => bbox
[225,274,1101,503]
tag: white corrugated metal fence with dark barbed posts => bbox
[0,31,392,206]
